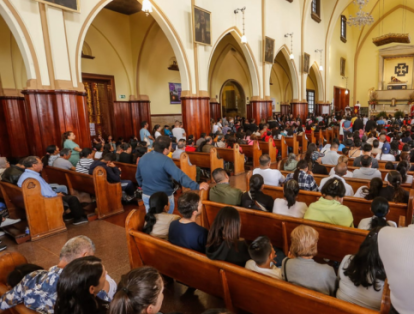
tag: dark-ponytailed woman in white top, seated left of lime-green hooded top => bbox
[273,180,308,218]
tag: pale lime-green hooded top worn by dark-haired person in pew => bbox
[303,197,354,227]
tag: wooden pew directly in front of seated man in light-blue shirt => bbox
[43,166,124,219]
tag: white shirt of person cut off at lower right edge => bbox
[378,225,414,314]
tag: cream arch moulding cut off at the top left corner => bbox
[0,1,37,81]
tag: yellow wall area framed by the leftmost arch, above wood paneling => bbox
[0,16,27,91]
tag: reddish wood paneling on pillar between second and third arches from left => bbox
[181,97,210,138]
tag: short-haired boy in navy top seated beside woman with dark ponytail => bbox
[168,192,208,253]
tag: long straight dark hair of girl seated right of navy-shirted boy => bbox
[206,206,241,250]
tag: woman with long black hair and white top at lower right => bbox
[336,228,386,311]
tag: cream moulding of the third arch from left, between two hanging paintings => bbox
[207,27,261,97]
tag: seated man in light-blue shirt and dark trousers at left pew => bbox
[17,156,88,225]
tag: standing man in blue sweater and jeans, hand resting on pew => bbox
[135,136,209,214]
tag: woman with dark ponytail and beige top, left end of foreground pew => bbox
[142,192,180,240]
